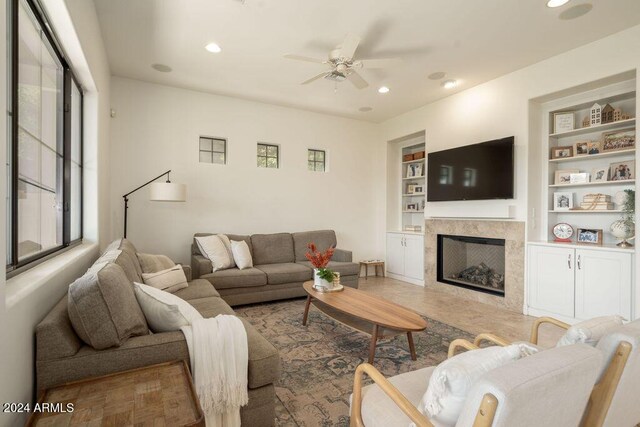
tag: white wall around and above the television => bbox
[382,26,640,221]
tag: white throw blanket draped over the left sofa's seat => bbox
[180,314,249,427]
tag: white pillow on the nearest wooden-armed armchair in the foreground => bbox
[418,344,535,426]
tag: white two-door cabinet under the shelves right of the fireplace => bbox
[528,244,633,320]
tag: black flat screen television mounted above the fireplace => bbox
[427,136,514,202]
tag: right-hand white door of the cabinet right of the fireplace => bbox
[576,249,631,320]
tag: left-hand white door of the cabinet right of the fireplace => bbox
[528,245,575,317]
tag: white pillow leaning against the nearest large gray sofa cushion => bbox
[133,283,202,332]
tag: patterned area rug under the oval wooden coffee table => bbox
[235,299,473,427]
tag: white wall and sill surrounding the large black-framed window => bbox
[0,0,110,426]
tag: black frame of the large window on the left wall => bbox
[5,0,84,278]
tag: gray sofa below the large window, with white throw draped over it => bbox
[36,239,280,427]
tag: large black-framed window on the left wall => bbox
[7,0,82,271]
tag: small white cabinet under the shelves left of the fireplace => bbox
[386,233,424,285]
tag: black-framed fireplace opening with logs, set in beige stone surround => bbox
[437,234,505,297]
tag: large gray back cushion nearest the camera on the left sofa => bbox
[68,262,149,350]
